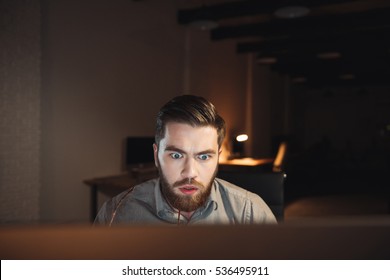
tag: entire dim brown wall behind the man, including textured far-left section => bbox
[0,0,269,223]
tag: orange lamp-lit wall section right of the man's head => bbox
[189,30,284,158]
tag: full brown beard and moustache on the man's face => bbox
[157,163,218,212]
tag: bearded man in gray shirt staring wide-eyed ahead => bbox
[95,95,276,225]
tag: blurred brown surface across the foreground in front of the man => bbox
[0,222,390,260]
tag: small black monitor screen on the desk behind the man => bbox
[126,136,154,166]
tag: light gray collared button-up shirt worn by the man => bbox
[95,178,276,225]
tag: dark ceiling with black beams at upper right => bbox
[177,0,390,86]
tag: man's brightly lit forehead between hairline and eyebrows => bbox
[161,122,218,149]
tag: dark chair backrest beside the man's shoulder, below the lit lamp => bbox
[218,170,285,221]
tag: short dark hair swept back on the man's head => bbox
[155,95,226,147]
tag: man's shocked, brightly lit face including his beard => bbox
[154,122,220,212]
